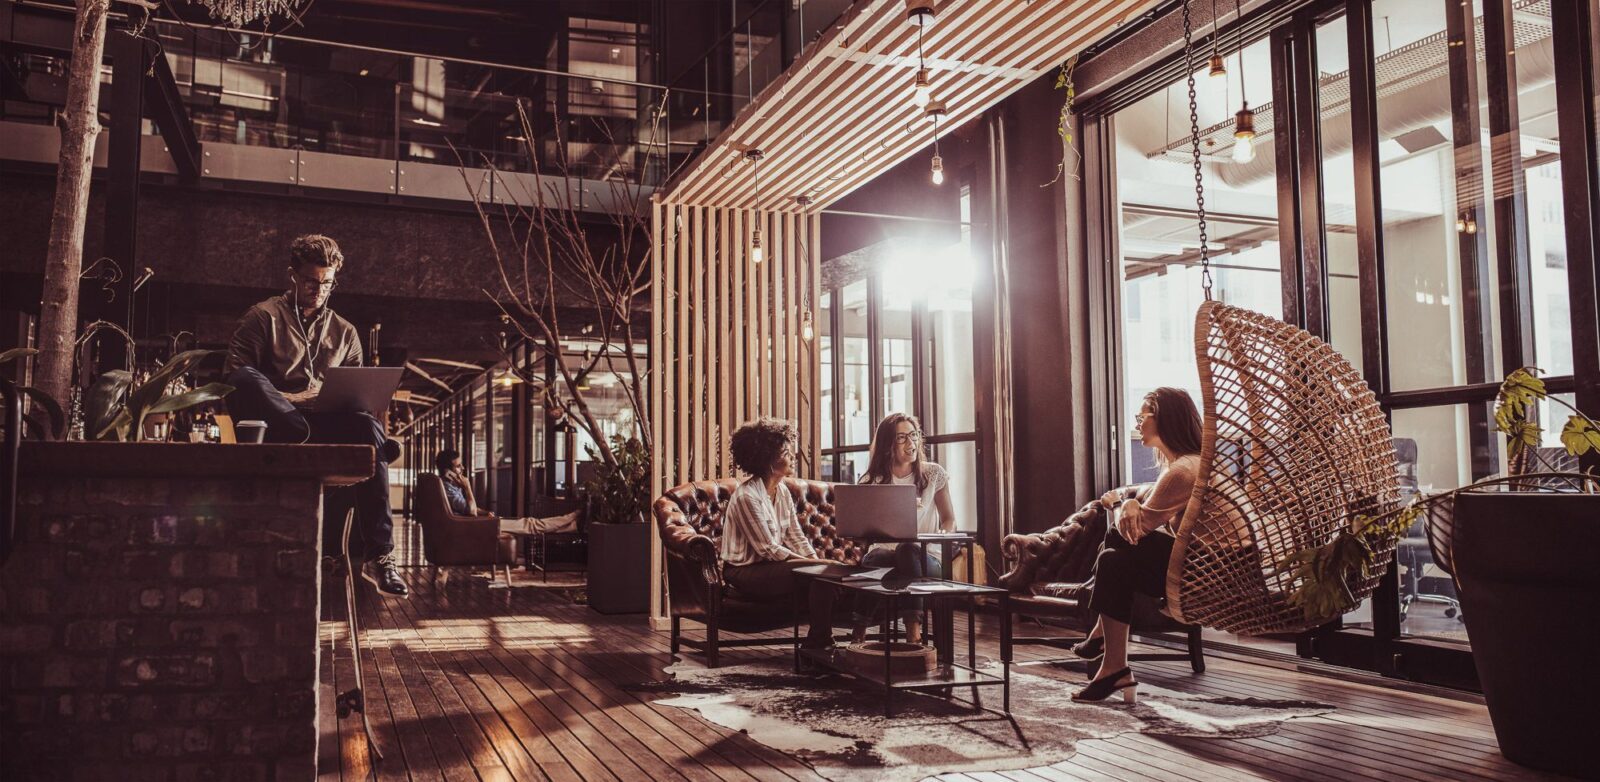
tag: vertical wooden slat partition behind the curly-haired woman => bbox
[650,201,821,496]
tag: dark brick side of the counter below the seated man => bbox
[0,470,322,782]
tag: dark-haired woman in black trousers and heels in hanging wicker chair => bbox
[1072,387,1200,704]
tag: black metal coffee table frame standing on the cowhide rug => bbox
[794,573,1011,716]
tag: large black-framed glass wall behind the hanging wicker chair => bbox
[1085,0,1600,683]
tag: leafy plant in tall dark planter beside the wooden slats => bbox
[582,435,650,614]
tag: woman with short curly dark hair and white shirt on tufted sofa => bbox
[722,417,835,649]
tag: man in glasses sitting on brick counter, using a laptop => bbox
[224,233,410,596]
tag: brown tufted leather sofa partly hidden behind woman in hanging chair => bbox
[998,502,1205,673]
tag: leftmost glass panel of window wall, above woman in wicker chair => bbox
[1112,42,1283,483]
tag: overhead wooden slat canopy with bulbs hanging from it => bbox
[664,0,1157,209]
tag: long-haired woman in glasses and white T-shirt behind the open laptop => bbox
[856,413,955,643]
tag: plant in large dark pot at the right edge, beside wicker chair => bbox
[1282,368,1600,777]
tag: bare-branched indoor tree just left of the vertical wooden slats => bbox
[462,101,666,467]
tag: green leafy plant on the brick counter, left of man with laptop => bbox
[83,350,234,441]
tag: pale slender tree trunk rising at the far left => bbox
[37,0,110,428]
